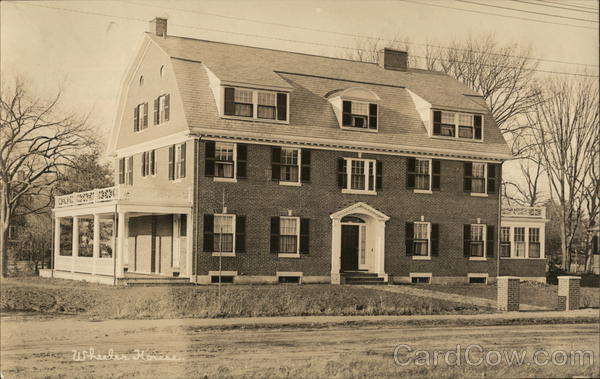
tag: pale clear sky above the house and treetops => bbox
[0,0,599,185]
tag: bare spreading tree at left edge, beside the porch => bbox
[0,80,94,276]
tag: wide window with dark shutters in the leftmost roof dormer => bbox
[223,87,288,121]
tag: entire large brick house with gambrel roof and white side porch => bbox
[45,19,546,283]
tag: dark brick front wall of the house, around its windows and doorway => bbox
[194,142,498,278]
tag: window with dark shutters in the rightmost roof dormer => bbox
[433,110,483,141]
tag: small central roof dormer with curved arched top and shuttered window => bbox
[325,87,381,132]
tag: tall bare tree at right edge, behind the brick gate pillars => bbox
[527,78,599,270]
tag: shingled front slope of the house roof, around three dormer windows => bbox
[147,33,510,159]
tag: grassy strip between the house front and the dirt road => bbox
[0,278,490,319]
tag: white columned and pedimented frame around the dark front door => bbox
[329,202,390,284]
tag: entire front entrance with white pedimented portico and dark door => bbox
[330,202,389,284]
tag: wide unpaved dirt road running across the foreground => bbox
[1,318,600,378]
